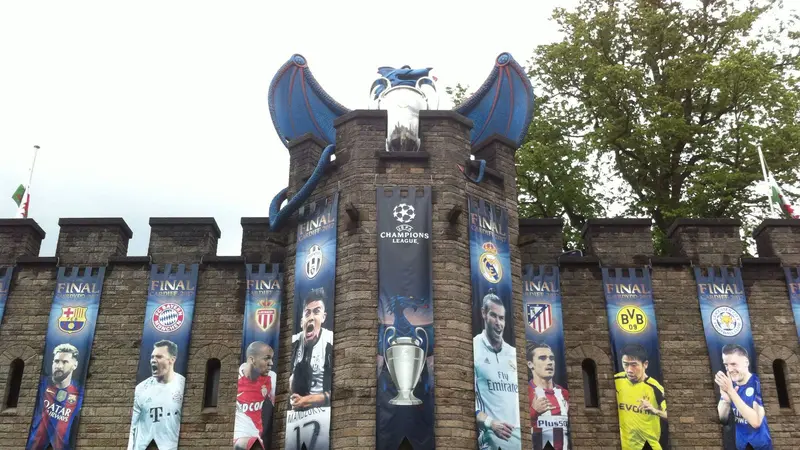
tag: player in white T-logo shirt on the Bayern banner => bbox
[128,340,186,450]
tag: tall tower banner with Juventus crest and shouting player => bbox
[285,194,339,450]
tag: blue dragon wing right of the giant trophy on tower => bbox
[455,53,534,145]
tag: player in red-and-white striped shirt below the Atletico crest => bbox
[525,343,569,450]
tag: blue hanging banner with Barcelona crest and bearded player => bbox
[25,267,105,450]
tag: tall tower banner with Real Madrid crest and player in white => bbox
[467,197,522,450]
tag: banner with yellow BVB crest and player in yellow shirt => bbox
[603,268,669,450]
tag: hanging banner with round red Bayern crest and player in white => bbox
[128,264,198,450]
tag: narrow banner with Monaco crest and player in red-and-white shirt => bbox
[233,264,283,450]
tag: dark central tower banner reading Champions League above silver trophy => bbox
[376,186,435,450]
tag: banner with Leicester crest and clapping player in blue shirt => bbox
[694,266,772,450]
